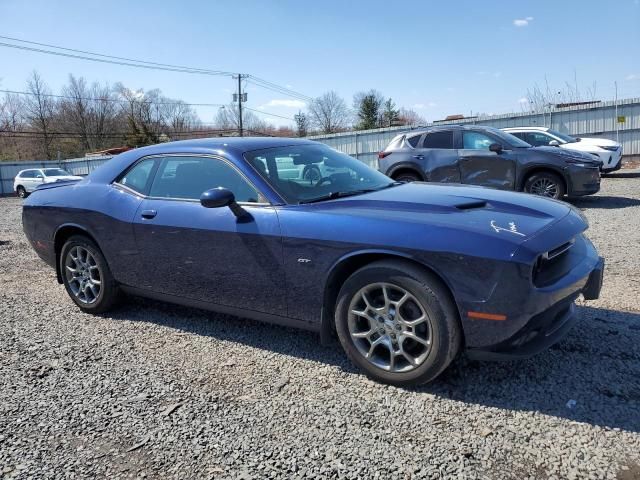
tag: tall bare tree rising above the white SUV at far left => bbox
[24,71,56,160]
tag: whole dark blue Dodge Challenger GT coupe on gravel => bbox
[22,138,603,386]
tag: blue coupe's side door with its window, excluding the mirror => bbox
[134,155,287,316]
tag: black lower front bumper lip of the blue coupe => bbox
[467,257,604,360]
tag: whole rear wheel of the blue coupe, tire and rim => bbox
[60,235,118,313]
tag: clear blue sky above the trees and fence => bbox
[0,0,640,124]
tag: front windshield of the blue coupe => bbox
[245,144,395,203]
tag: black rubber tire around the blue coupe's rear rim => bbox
[59,235,120,313]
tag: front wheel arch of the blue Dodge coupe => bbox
[320,249,464,345]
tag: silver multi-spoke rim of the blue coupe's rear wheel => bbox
[65,246,102,304]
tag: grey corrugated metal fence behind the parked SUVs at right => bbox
[309,98,640,167]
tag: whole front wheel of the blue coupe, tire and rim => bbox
[336,261,462,386]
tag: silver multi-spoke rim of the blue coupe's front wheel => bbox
[348,283,432,373]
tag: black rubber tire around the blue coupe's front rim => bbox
[335,260,462,387]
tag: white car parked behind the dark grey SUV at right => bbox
[502,127,622,173]
